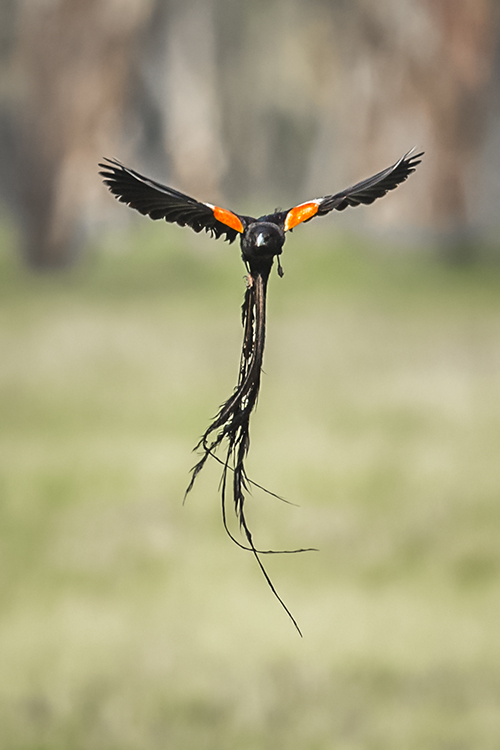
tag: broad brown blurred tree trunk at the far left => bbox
[10,0,150,268]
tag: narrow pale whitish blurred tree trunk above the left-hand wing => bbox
[141,0,227,200]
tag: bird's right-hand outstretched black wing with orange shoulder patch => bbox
[280,149,423,231]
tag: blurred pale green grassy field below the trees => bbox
[0,223,500,750]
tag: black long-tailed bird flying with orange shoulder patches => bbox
[99,150,422,633]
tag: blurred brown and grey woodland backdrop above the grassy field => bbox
[0,0,500,266]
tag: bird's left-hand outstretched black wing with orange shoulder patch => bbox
[99,159,253,242]
